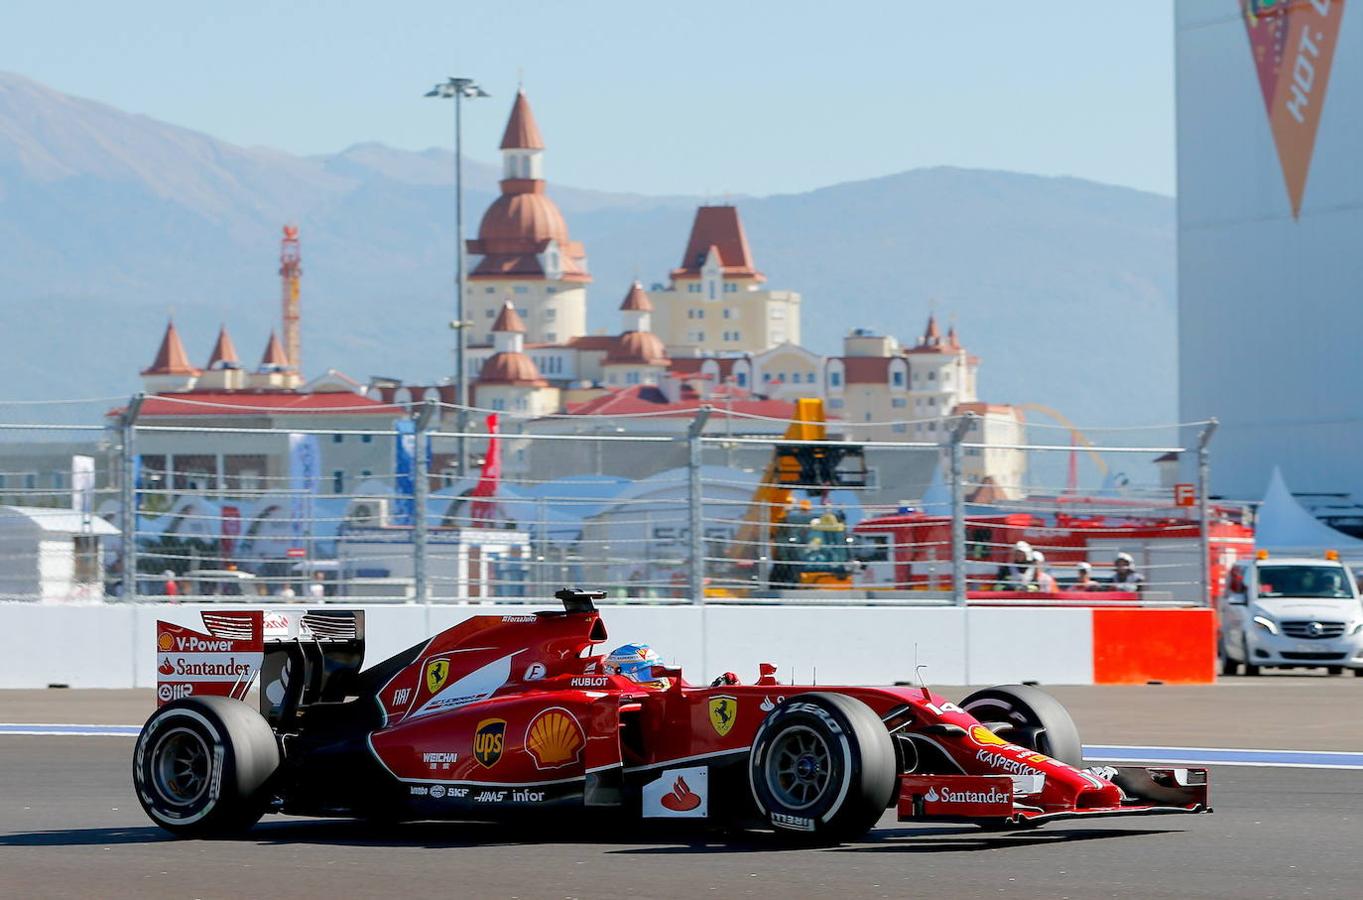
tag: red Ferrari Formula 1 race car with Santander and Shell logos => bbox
[134,590,1208,841]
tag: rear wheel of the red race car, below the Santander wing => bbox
[132,697,279,837]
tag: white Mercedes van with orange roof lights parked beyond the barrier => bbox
[1217,551,1363,675]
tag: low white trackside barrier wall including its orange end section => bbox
[0,604,1216,689]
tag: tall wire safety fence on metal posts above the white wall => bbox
[0,398,1253,605]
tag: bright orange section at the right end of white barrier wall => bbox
[1093,610,1216,685]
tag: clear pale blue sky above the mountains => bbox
[0,0,1174,195]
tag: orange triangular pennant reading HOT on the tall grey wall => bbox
[1239,0,1344,218]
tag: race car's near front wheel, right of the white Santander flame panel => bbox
[748,693,898,843]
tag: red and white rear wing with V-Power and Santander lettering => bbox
[155,608,364,721]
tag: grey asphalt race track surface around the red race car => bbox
[0,675,1363,900]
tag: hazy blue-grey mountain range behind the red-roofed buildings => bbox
[0,74,1175,424]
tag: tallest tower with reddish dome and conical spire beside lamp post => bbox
[463,90,592,368]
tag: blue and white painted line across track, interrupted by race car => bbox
[0,723,1363,769]
